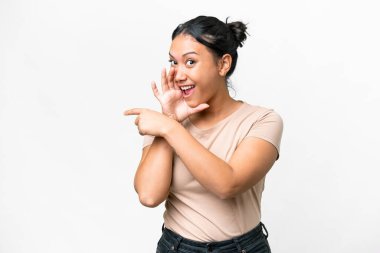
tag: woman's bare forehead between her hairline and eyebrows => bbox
[169,34,209,57]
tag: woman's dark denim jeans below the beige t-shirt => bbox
[156,222,271,253]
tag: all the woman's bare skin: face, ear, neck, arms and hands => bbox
[124,35,278,207]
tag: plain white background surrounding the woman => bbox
[0,0,380,253]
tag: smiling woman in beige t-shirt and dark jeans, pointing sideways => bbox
[125,16,283,252]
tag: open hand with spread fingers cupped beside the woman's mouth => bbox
[152,68,209,122]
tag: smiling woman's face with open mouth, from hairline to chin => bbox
[169,34,225,107]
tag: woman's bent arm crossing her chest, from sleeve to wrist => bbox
[162,121,278,199]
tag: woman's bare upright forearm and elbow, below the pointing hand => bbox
[134,137,173,207]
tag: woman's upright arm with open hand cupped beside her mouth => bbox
[134,68,208,207]
